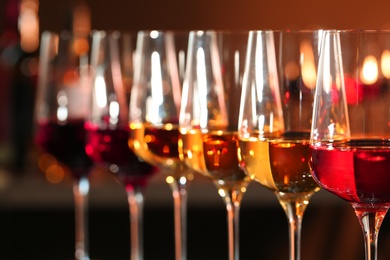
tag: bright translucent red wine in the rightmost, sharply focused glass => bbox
[310,140,390,206]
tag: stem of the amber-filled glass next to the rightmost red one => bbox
[276,192,312,260]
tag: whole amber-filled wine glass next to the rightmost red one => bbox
[239,30,321,260]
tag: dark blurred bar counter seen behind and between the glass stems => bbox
[0,170,390,260]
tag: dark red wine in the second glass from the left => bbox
[85,122,156,186]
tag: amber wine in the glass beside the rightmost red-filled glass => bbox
[239,133,319,193]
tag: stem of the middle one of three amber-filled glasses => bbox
[223,189,244,260]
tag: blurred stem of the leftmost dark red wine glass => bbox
[73,177,89,260]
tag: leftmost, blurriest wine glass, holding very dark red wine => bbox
[35,31,92,260]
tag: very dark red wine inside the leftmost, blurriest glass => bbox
[35,119,92,179]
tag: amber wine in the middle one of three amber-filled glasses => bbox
[180,130,249,187]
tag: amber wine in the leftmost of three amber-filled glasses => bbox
[129,124,185,177]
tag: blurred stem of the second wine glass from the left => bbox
[126,186,144,260]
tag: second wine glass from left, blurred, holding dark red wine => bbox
[85,31,156,260]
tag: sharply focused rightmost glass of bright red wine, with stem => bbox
[310,31,390,260]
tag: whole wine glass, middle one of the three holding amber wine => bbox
[179,30,249,259]
